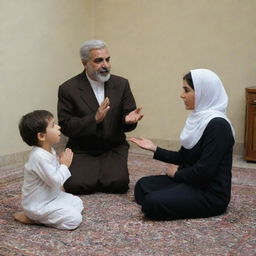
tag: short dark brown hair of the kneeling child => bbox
[19,110,53,146]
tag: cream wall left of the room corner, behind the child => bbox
[0,0,94,155]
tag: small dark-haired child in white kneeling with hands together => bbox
[14,110,83,230]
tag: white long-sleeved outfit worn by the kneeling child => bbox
[22,146,83,229]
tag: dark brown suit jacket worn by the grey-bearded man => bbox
[58,71,136,155]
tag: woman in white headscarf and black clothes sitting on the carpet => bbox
[129,69,234,220]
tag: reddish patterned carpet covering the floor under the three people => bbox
[0,154,256,256]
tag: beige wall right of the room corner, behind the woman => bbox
[95,0,256,147]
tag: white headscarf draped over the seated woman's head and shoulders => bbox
[180,69,234,149]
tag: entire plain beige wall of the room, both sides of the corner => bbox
[0,0,256,155]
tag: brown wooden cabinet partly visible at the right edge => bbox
[244,87,256,162]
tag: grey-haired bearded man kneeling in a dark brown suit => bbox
[58,40,143,194]
